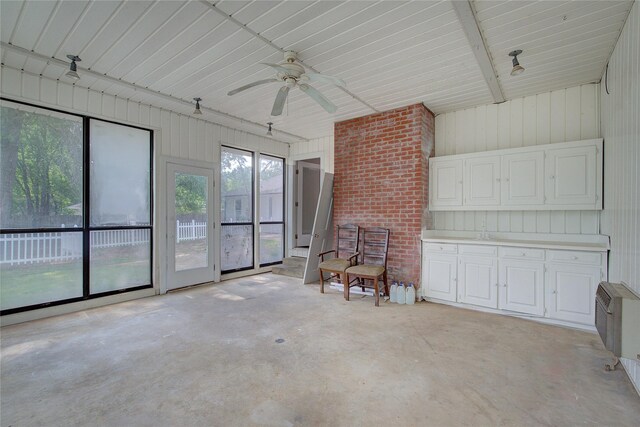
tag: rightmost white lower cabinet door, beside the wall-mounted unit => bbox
[547,264,600,325]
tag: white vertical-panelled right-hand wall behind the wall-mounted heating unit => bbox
[600,2,640,393]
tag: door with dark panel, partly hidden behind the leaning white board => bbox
[295,161,320,247]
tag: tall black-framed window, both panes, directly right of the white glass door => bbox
[220,147,253,273]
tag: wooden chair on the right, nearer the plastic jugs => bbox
[345,227,389,307]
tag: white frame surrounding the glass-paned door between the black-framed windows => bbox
[155,155,220,294]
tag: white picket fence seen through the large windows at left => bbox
[0,229,150,265]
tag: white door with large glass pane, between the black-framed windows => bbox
[167,163,214,290]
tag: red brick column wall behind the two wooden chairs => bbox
[333,104,434,285]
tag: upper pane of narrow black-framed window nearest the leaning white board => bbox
[260,155,284,222]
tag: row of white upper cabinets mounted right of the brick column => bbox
[429,139,602,211]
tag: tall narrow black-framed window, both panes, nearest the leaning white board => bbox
[260,154,284,266]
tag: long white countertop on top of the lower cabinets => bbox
[422,230,609,252]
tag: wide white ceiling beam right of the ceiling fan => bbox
[451,0,505,103]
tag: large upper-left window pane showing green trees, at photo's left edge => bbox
[0,101,83,229]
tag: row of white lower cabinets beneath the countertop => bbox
[422,243,606,326]
